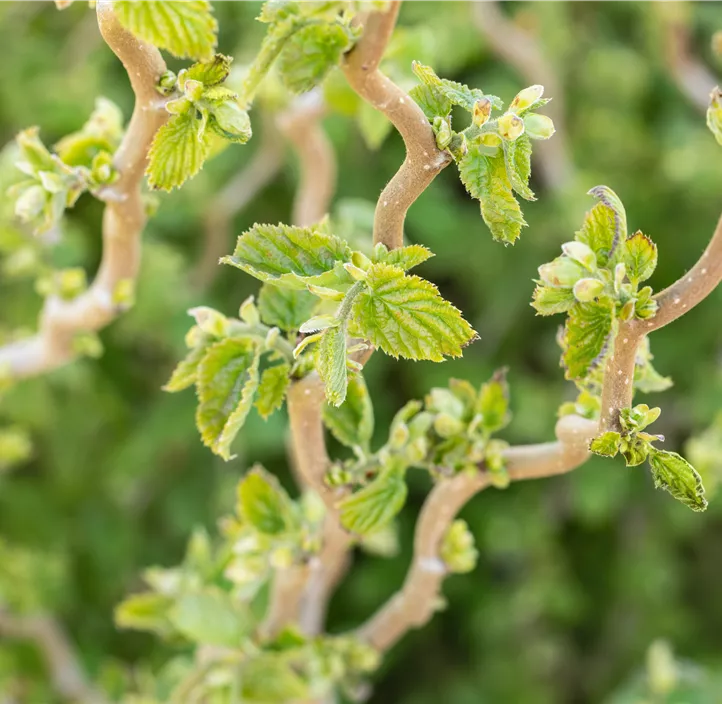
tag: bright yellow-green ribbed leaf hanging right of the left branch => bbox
[146,110,210,191]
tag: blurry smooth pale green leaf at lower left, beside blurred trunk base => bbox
[170,588,251,648]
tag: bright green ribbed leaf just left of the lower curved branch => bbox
[339,467,408,536]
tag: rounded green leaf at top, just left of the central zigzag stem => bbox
[278,23,351,93]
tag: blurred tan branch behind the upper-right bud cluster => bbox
[471,0,574,191]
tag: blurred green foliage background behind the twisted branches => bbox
[0,0,722,704]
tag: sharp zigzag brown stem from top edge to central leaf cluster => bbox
[343,0,451,249]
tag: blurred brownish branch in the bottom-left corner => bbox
[0,610,106,704]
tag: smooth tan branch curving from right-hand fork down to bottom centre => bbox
[358,416,597,652]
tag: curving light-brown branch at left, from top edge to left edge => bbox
[0,0,169,378]
